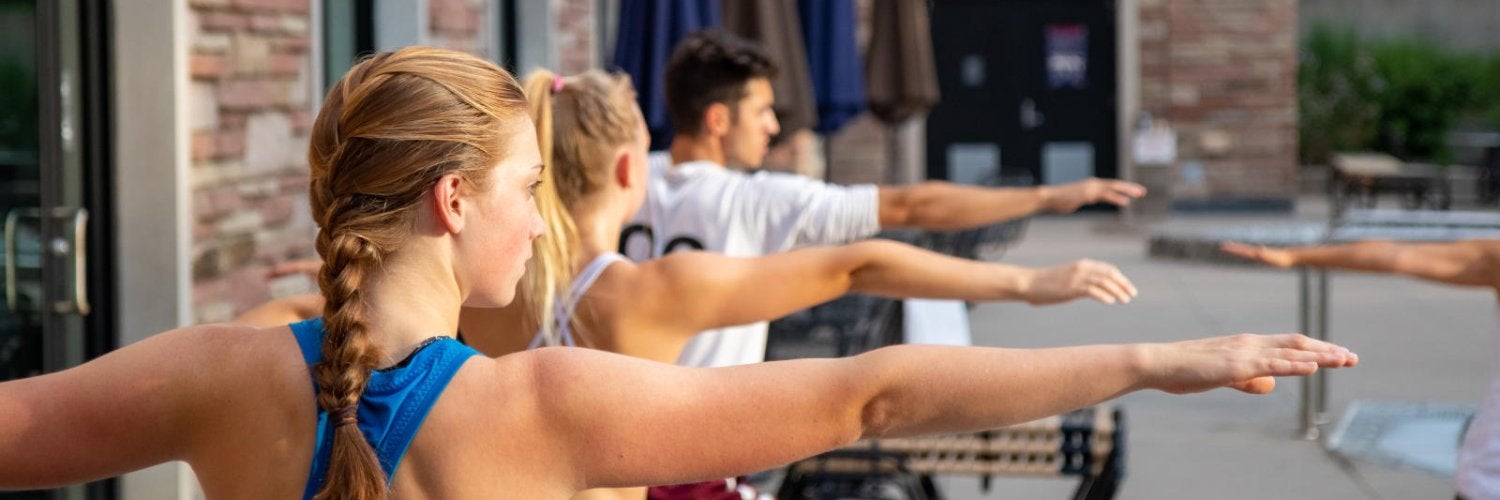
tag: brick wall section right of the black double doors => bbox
[1139,0,1298,198]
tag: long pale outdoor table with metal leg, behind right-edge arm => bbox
[1148,209,1500,440]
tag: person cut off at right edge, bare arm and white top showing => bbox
[1224,240,1500,500]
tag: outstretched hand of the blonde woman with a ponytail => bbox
[1022,258,1139,305]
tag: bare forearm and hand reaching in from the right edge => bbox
[1223,240,1500,287]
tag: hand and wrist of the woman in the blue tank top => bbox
[1143,333,1359,393]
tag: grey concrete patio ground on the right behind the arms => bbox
[939,200,1497,500]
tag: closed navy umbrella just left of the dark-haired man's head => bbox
[612,0,723,150]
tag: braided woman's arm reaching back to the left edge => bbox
[0,321,273,489]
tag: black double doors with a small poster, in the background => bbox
[927,0,1118,198]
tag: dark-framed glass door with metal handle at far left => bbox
[0,0,113,500]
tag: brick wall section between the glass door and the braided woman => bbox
[189,0,314,321]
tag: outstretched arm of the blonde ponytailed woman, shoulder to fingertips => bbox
[623,240,1136,335]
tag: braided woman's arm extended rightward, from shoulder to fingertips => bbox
[522,328,1358,488]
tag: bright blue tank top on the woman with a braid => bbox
[291,318,479,498]
